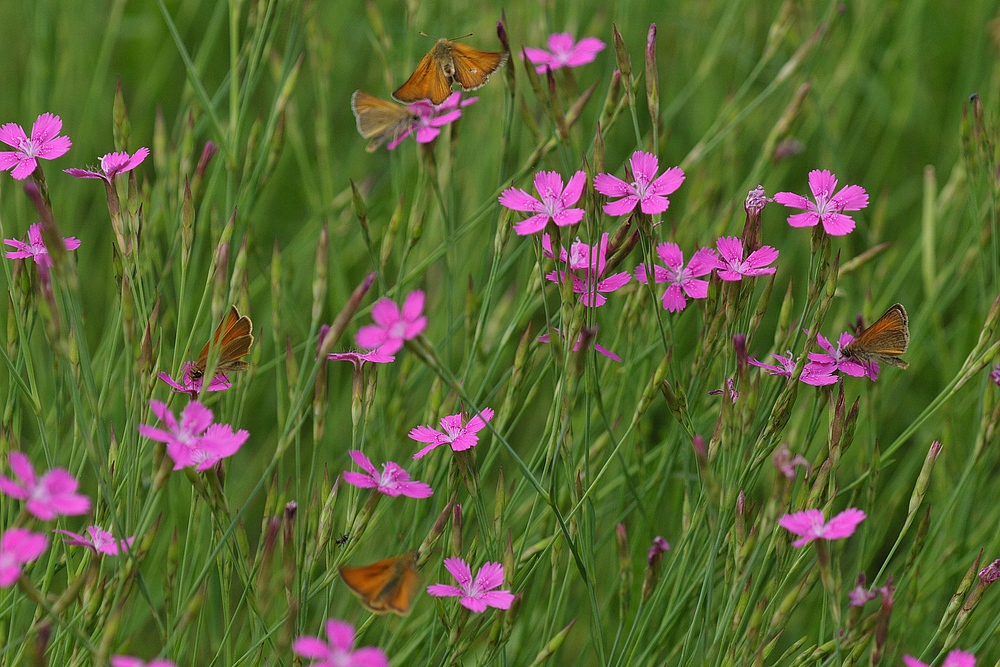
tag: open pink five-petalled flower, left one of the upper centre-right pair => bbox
[499,171,587,236]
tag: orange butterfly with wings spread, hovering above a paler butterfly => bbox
[392,39,507,104]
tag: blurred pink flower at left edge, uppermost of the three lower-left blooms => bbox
[0,452,90,521]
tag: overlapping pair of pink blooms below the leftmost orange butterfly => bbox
[139,399,250,471]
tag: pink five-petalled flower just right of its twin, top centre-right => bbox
[594,151,684,215]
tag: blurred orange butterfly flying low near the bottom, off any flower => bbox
[339,551,419,616]
